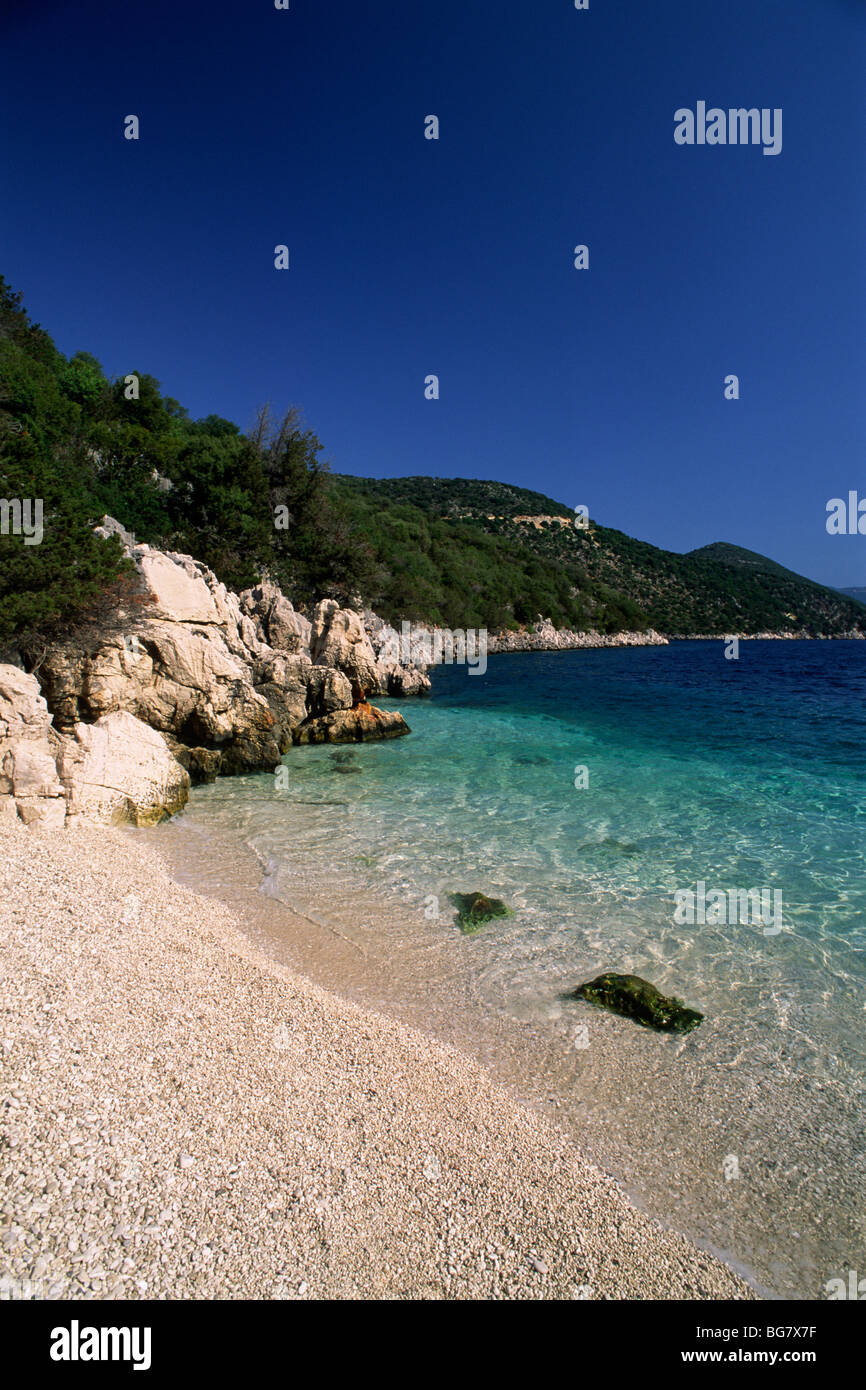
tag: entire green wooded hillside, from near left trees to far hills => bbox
[0,277,866,655]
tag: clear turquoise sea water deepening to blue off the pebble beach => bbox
[157,642,866,1298]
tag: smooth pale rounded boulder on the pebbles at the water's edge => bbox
[58,710,189,826]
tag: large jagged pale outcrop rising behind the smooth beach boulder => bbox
[32,517,423,781]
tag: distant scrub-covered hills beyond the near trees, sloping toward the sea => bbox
[332,474,866,637]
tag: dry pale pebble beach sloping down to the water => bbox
[0,827,756,1300]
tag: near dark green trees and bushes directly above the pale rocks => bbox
[0,277,373,652]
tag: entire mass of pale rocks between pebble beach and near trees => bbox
[0,517,430,828]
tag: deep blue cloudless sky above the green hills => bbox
[0,0,866,585]
